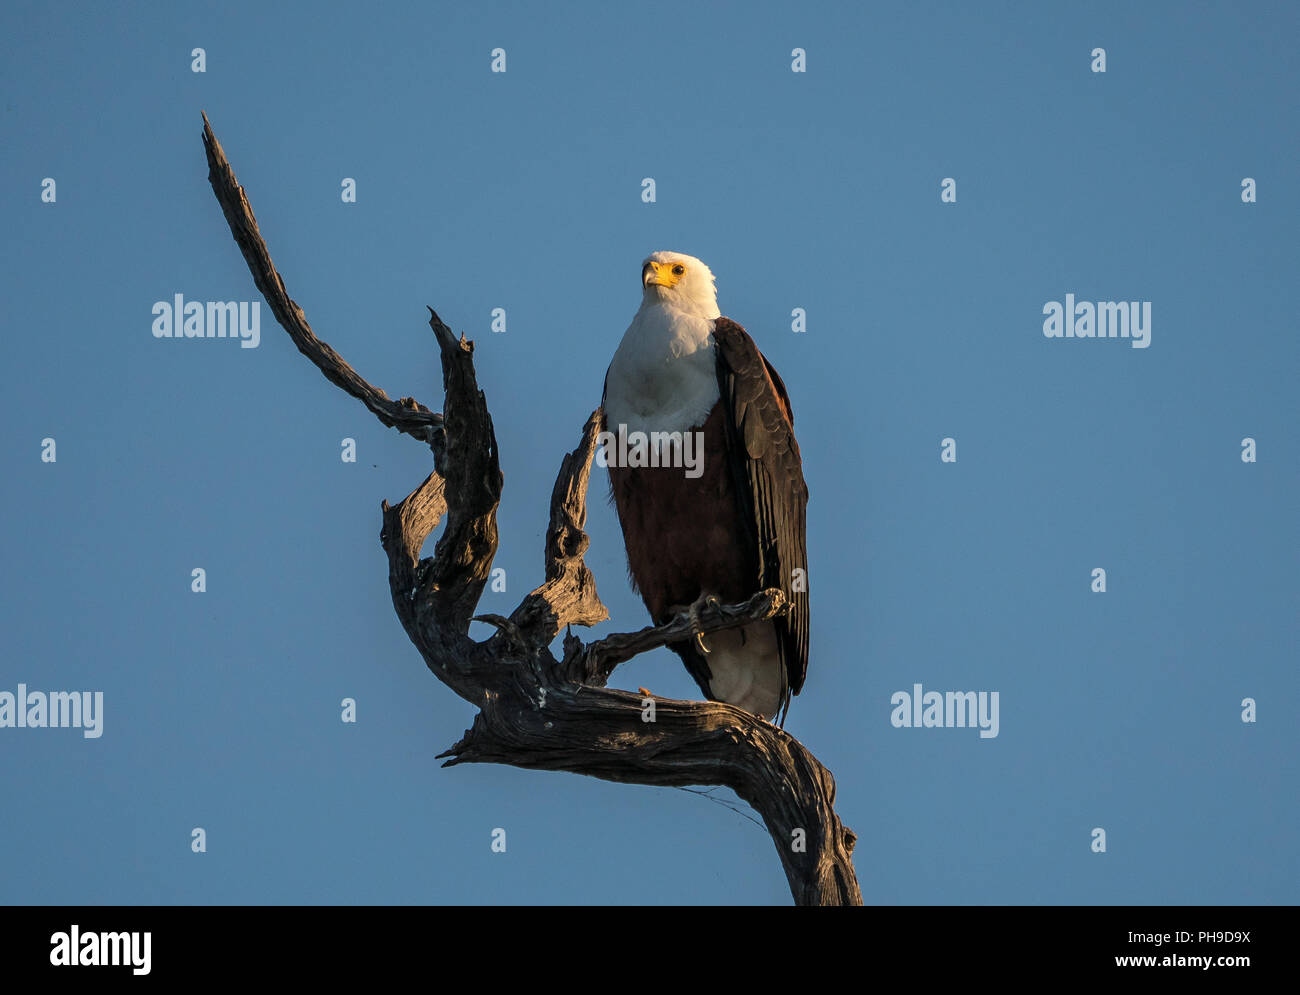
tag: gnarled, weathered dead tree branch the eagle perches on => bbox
[203,116,862,905]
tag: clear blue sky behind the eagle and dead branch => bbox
[0,0,1300,904]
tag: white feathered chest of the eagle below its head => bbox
[605,302,719,433]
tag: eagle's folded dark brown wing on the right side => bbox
[714,317,809,706]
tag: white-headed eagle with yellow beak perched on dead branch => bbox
[601,252,809,723]
